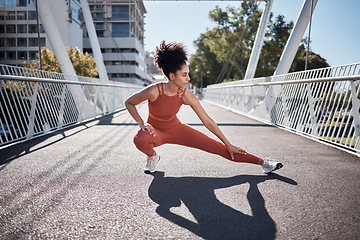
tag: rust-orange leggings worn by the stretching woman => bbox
[134,123,259,164]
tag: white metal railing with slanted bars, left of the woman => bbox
[0,64,143,148]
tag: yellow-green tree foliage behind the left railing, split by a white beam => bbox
[28,47,98,77]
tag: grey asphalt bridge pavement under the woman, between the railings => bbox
[0,102,360,239]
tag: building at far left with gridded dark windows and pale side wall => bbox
[0,0,83,66]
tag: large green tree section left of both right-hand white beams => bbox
[189,2,261,86]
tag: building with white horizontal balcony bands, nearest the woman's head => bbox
[84,0,152,83]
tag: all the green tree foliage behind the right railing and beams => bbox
[189,1,329,87]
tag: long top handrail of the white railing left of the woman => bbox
[0,75,143,88]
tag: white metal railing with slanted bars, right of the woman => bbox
[204,63,360,154]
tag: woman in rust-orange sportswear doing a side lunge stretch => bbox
[125,41,283,173]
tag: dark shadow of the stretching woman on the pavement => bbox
[149,172,297,239]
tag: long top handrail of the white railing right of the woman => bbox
[208,75,360,89]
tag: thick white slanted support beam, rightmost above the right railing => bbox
[274,0,318,76]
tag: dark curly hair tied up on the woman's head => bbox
[154,41,188,78]
